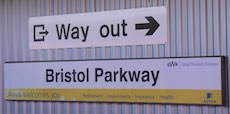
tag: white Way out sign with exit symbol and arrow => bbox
[29,6,167,49]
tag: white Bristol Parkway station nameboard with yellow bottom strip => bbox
[4,57,224,105]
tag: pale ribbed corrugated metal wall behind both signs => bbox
[0,0,230,114]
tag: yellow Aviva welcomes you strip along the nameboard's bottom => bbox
[5,89,222,105]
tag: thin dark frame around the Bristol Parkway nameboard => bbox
[5,56,227,105]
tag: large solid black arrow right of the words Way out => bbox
[136,16,160,36]
